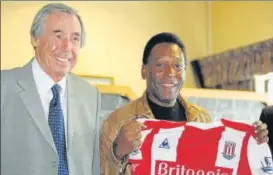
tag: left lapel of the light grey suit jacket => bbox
[18,63,56,152]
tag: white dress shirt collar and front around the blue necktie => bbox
[32,58,68,143]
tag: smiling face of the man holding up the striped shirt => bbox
[142,43,185,106]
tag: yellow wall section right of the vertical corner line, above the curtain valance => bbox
[211,1,273,53]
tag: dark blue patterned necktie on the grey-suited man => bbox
[48,84,68,175]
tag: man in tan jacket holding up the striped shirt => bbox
[100,33,268,175]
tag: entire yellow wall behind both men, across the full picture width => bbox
[1,1,273,96]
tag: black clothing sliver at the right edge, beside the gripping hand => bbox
[260,106,273,154]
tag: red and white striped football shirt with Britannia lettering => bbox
[129,119,273,175]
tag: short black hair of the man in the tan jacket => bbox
[142,32,187,65]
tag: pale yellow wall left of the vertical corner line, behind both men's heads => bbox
[1,2,208,95]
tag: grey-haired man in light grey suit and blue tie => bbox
[1,3,100,175]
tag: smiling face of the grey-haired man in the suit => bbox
[31,12,81,81]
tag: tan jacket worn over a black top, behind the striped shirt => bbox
[100,93,211,175]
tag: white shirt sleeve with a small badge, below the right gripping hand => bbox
[247,137,273,175]
